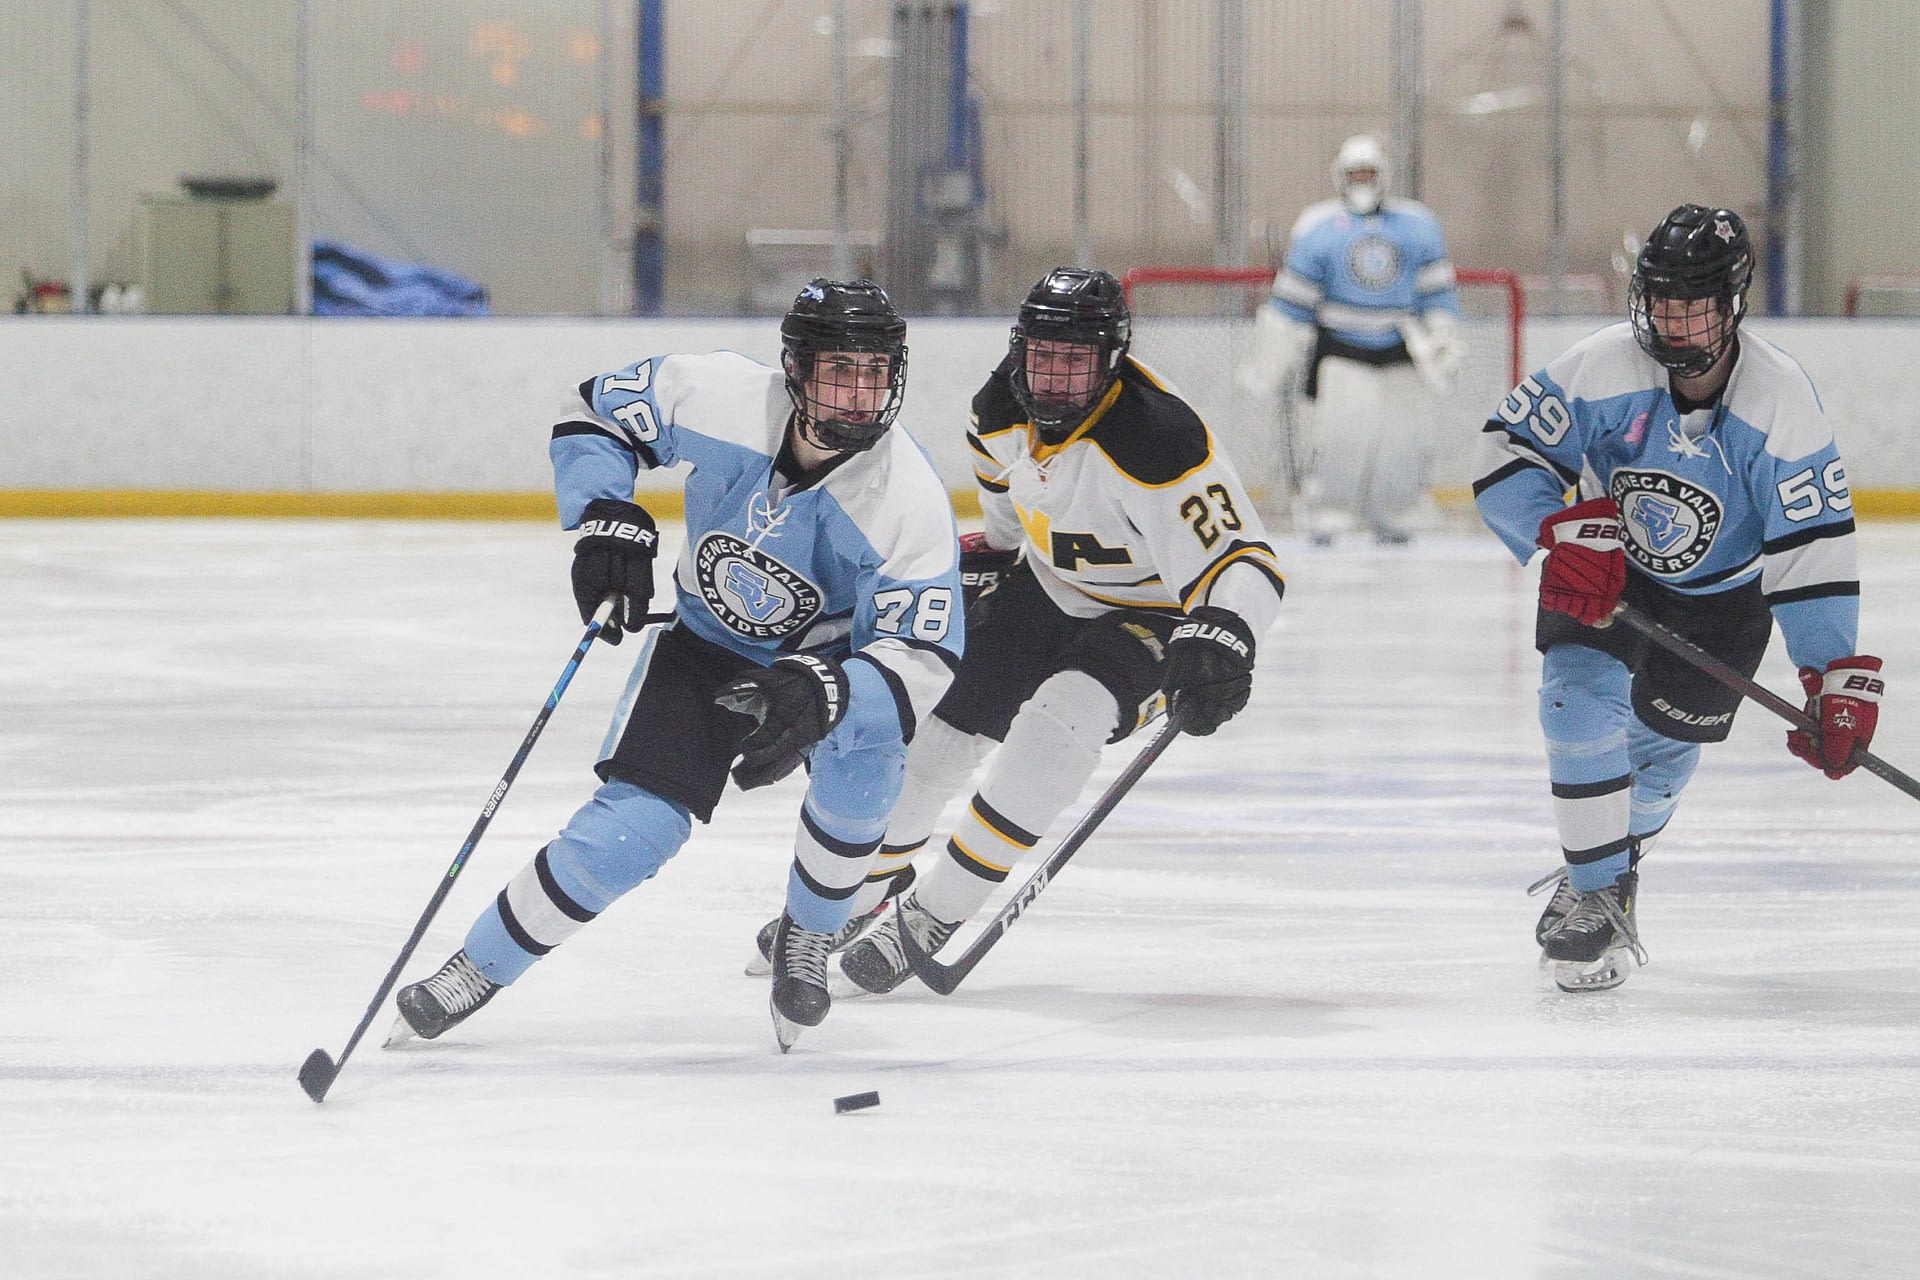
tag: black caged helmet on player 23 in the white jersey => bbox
[1008,267,1133,443]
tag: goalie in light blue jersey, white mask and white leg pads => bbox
[1240,134,1461,543]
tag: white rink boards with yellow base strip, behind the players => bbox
[11,317,1920,495]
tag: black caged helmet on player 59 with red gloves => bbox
[1626,205,1753,378]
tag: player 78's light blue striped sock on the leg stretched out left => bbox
[467,781,693,986]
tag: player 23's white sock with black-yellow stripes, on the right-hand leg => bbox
[914,672,1119,923]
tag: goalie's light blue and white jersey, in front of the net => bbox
[1271,200,1459,351]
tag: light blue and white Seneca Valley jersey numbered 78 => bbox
[549,351,966,739]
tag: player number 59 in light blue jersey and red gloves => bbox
[1475,205,1884,992]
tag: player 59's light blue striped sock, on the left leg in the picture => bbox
[1540,645,1634,892]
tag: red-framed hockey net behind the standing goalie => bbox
[1121,267,1526,526]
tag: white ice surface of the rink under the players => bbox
[0,522,1920,1280]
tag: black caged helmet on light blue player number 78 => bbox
[780,278,906,453]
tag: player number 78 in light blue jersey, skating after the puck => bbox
[390,280,964,1052]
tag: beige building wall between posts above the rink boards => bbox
[0,0,1889,313]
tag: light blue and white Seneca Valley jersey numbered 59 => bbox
[1473,322,1860,668]
